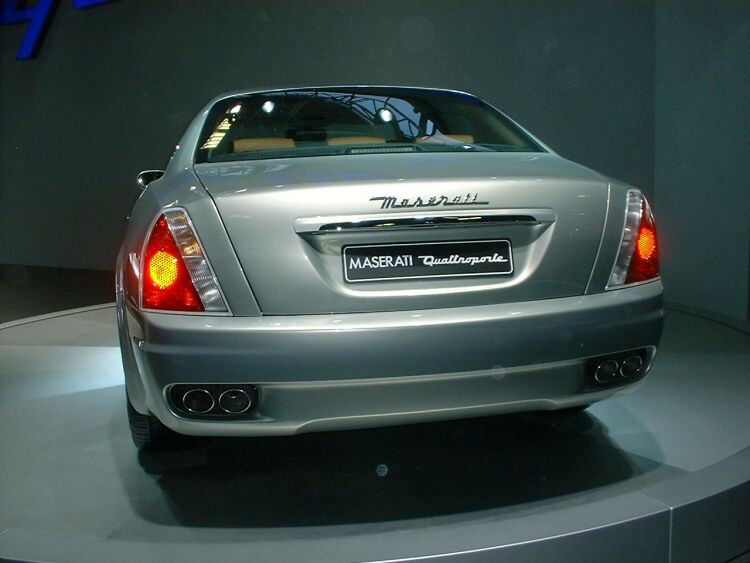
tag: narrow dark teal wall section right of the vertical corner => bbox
[654,0,750,319]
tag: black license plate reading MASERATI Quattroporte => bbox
[343,239,513,283]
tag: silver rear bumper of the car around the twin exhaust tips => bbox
[126,281,664,435]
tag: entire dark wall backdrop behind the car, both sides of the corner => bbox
[0,0,750,326]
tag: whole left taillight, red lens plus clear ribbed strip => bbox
[141,209,227,312]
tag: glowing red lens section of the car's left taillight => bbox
[141,215,204,311]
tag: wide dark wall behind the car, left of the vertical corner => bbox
[0,0,654,269]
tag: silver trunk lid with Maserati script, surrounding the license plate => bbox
[195,153,608,315]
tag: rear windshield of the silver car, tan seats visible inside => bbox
[195,88,543,163]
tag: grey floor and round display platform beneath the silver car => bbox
[0,306,750,561]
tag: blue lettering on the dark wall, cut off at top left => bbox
[0,0,114,60]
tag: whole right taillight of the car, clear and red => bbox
[607,190,659,288]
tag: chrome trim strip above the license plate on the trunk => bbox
[294,209,556,235]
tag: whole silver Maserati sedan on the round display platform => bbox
[117,86,663,449]
